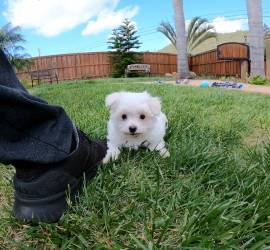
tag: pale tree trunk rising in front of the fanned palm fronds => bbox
[173,0,189,80]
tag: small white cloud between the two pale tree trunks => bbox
[210,17,247,33]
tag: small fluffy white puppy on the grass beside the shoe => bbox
[103,92,170,163]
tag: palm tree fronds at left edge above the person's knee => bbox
[0,23,32,70]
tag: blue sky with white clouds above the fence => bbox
[0,0,270,56]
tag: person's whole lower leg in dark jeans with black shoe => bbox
[0,50,106,222]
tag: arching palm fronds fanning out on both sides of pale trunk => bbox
[157,17,217,55]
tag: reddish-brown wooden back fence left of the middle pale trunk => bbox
[17,52,176,81]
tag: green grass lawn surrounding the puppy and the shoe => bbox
[0,79,270,249]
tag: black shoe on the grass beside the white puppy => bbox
[13,131,107,223]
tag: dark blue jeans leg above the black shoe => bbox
[0,50,77,164]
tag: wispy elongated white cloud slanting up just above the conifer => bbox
[82,6,139,35]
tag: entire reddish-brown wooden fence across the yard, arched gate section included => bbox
[18,43,253,80]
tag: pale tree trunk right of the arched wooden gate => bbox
[246,0,265,76]
